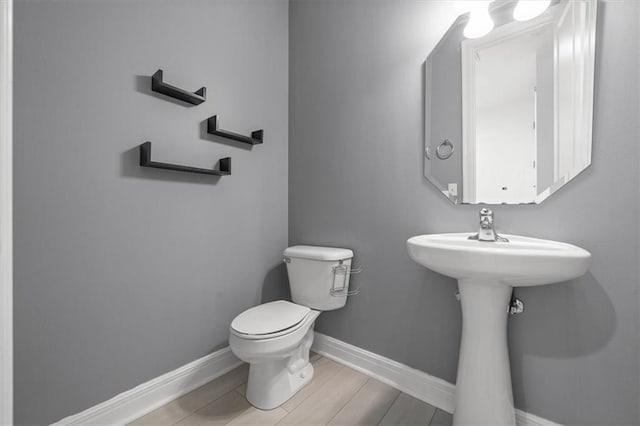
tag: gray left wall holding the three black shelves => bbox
[14,0,288,424]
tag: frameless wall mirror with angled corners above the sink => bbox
[424,0,597,204]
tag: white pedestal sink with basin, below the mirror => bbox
[407,233,591,425]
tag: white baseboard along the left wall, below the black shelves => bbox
[54,347,242,426]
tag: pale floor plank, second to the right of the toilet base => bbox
[279,367,368,425]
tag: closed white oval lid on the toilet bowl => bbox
[231,300,311,335]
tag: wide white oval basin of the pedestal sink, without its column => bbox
[407,233,591,287]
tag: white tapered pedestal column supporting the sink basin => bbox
[453,279,516,426]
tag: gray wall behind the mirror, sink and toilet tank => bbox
[289,0,640,424]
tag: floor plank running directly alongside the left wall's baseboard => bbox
[130,364,249,426]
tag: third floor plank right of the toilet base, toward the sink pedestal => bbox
[329,379,400,425]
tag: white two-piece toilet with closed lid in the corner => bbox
[229,246,353,410]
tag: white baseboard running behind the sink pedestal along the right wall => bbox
[311,332,560,426]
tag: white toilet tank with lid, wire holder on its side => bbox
[283,246,353,311]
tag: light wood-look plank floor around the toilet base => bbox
[130,355,452,426]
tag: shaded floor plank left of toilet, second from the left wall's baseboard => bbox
[176,390,251,426]
